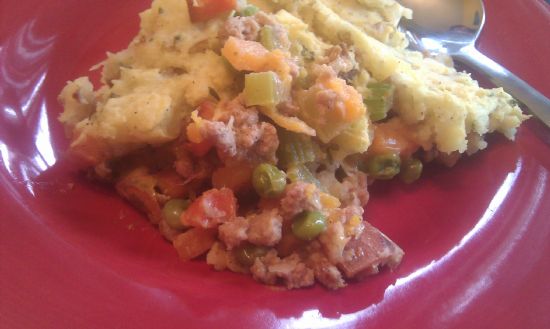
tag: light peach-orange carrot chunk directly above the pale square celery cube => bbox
[222,37,269,72]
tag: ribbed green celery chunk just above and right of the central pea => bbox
[277,129,316,168]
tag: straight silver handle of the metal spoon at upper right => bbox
[454,46,550,127]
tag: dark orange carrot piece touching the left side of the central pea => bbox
[212,164,254,192]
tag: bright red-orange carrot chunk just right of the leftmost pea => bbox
[181,188,237,228]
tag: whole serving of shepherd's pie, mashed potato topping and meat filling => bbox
[59,0,527,289]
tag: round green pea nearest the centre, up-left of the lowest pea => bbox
[252,163,286,198]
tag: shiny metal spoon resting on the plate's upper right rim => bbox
[400,0,550,127]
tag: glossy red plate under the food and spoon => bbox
[0,0,550,328]
